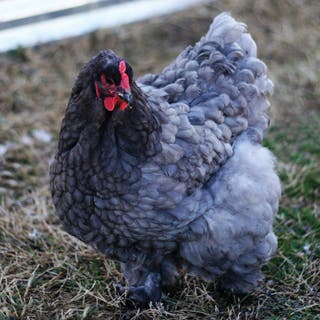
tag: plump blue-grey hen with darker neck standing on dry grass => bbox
[50,13,280,304]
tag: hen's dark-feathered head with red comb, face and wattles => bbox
[94,50,133,111]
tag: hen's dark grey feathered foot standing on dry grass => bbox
[117,272,162,306]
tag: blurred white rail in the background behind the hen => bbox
[0,0,203,51]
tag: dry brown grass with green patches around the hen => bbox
[0,0,320,320]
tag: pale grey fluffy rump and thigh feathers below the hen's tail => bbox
[180,134,281,292]
